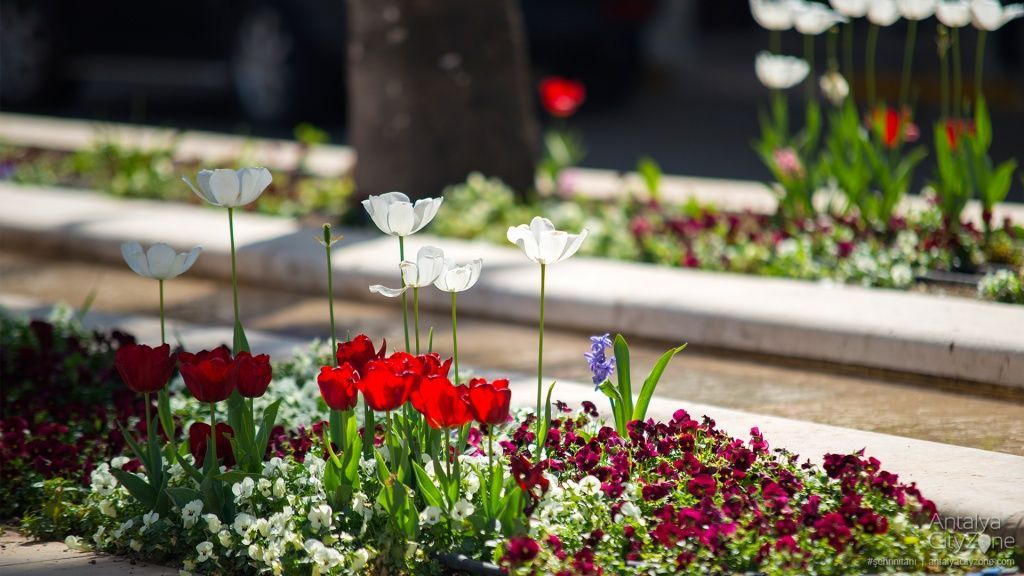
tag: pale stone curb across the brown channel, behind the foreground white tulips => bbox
[0,183,1024,388]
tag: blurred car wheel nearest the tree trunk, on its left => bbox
[231,6,298,122]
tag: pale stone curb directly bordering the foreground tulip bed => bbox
[0,296,1024,545]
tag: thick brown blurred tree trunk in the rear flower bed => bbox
[348,0,538,198]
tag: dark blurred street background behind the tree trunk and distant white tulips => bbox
[0,0,1024,195]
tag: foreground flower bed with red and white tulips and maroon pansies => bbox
[3,168,1014,575]
